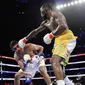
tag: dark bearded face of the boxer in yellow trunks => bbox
[40,7,51,20]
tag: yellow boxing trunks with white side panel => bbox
[52,30,77,66]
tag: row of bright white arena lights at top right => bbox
[56,0,85,9]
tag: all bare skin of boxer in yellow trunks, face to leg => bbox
[19,7,69,85]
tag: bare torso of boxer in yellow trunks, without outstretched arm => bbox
[46,11,69,36]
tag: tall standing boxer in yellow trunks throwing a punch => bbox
[19,4,77,85]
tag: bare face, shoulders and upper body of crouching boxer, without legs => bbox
[14,43,43,65]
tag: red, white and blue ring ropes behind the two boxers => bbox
[0,53,85,84]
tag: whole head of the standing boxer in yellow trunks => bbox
[40,4,52,20]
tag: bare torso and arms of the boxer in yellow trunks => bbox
[26,8,69,40]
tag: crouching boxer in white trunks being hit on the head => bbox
[10,41,52,85]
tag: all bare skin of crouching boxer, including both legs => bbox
[14,43,51,85]
